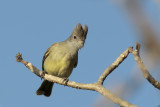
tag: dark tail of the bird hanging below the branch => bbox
[36,80,54,97]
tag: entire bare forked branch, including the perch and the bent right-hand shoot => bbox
[16,43,160,107]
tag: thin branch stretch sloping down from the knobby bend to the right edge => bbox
[129,43,160,89]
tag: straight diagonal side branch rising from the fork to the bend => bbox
[98,47,133,84]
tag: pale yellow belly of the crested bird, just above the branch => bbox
[44,52,75,78]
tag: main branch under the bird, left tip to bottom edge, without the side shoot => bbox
[16,53,137,107]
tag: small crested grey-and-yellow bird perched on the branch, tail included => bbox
[36,23,88,97]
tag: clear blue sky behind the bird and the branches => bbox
[0,0,160,107]
